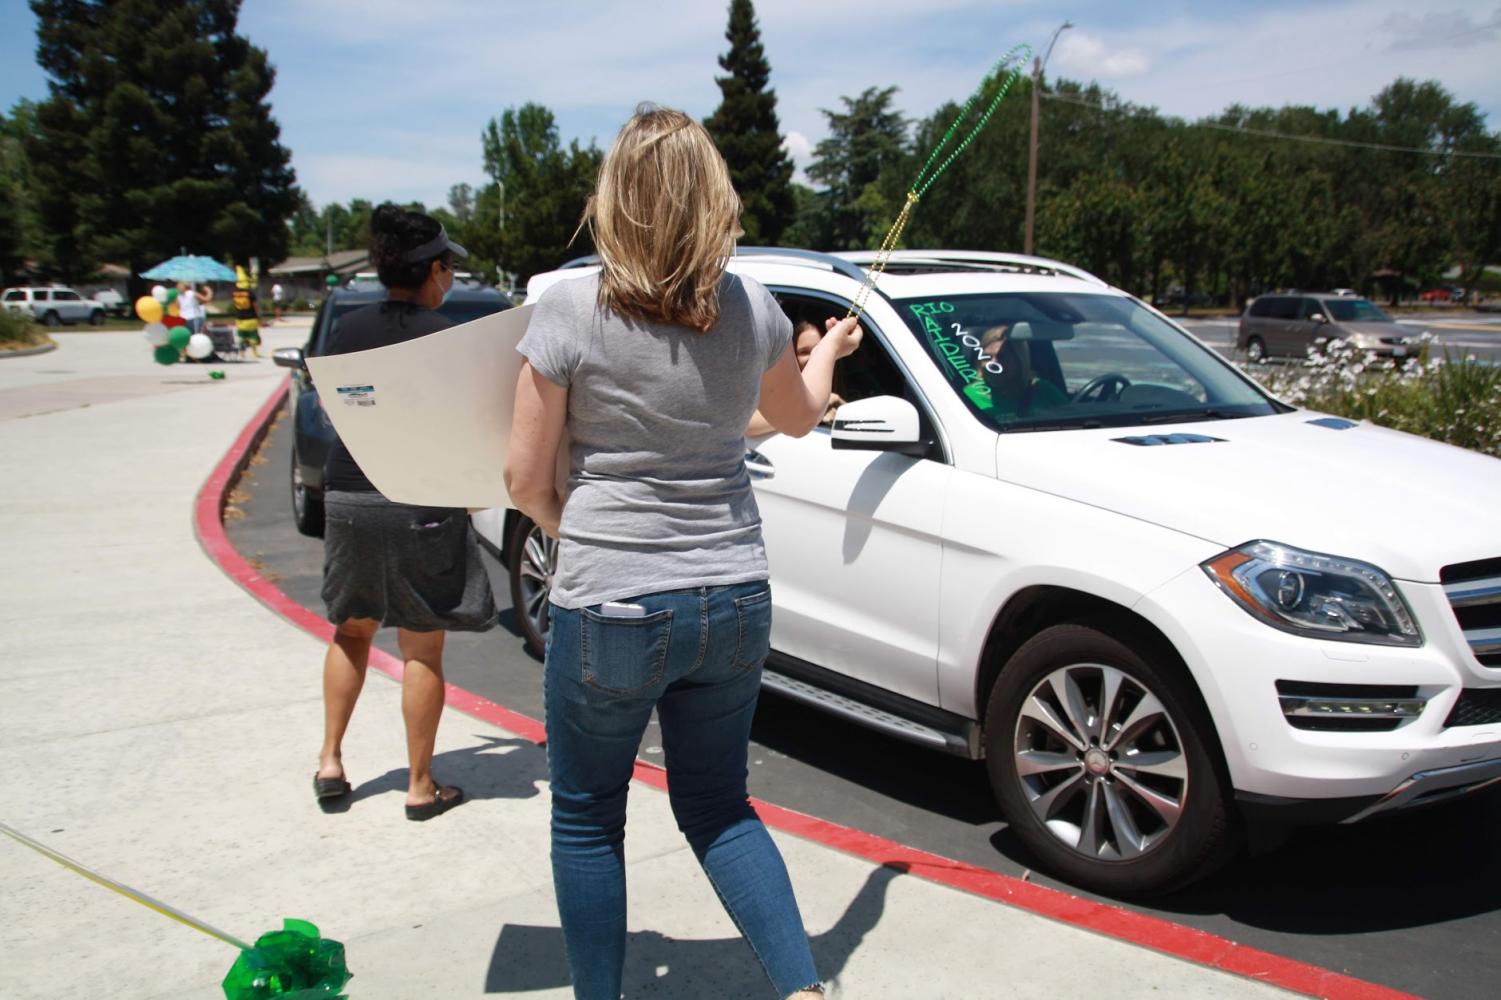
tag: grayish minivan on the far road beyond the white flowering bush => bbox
[1235,291,1417,362]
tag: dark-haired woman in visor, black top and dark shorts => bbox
[314,204,495,820]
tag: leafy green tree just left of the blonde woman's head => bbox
[474,104,603,278]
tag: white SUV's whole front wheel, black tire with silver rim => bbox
[985,625,1241,896]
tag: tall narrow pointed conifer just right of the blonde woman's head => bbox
[704,0,797,246]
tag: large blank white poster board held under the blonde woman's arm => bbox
[306,305,534,508]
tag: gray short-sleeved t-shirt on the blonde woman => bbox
[516,273,793,608]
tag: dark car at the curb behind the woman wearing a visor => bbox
[267,285,512,536]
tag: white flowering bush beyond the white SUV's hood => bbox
[1247,333,1501,458]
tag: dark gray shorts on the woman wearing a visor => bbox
[323,492,495,632]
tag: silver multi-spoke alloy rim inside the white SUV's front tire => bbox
[1013,664,1189,860]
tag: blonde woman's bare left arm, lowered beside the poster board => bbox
[506,362,567,538]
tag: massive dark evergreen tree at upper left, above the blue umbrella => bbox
[29,0,299,288]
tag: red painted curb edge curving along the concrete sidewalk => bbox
[194,380,1415,1000]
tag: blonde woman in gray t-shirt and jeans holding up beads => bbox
[506,105,862,1000]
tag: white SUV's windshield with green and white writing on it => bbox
[895,293,1283,431]
